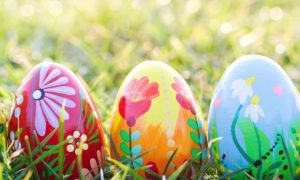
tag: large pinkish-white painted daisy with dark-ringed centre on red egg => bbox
[32,65,76,136]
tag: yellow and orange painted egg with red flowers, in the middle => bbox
[110,61,208,178]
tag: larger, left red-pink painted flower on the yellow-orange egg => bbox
[119,76,159,127]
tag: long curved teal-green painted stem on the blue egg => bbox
[231,105,254,164]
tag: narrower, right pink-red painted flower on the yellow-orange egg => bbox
[172,77,196,115]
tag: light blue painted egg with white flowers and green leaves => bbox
[208,55,300,179]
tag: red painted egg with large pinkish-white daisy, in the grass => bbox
[8,62,105,179]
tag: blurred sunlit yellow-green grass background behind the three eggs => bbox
[0,0,300,121]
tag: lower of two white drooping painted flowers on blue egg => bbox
[245,96,265,122]
